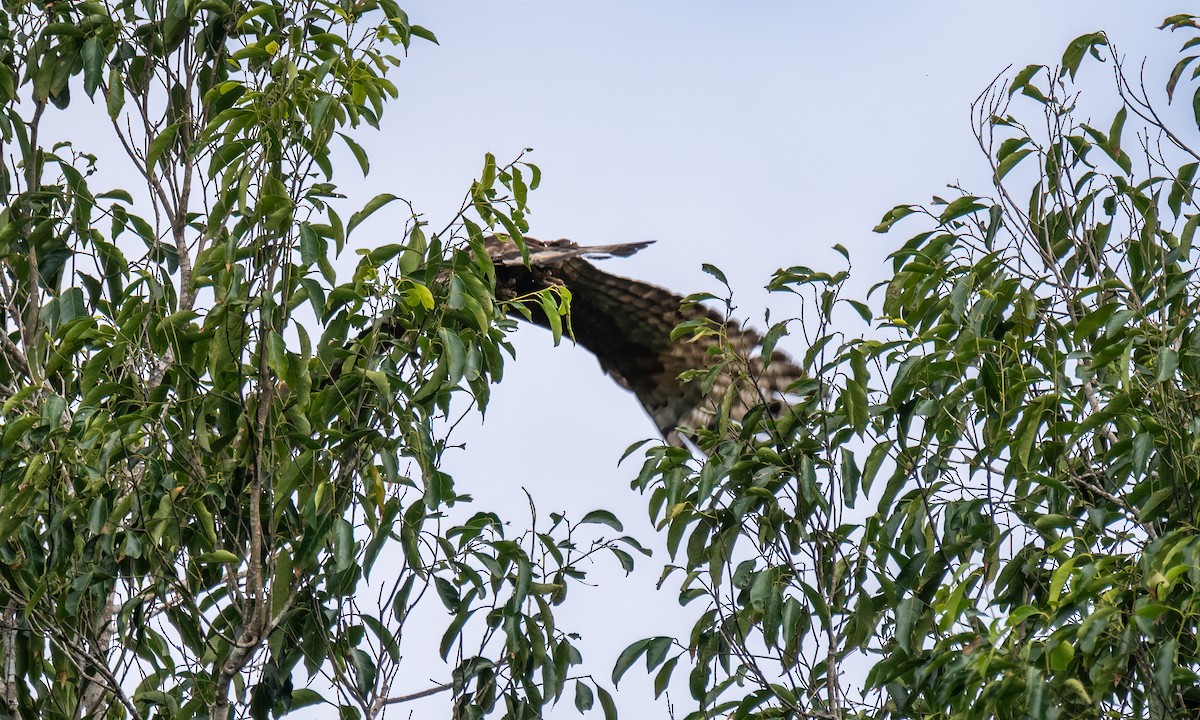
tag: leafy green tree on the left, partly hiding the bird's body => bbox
[0,0,636,719]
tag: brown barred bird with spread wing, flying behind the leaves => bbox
[484,235,804,446]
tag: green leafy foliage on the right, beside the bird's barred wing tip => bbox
[614,16,1200,719]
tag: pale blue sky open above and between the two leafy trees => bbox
[347,0,1190,718]
